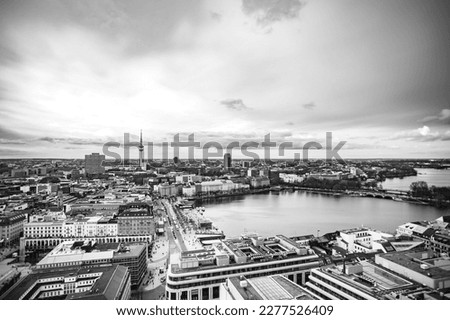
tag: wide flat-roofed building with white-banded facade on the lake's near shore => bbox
[166,235,320,300]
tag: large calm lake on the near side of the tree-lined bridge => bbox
[201,191,450,237]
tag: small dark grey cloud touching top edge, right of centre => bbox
[242,0,304,26]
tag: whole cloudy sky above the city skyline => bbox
[0,0,450,158]
